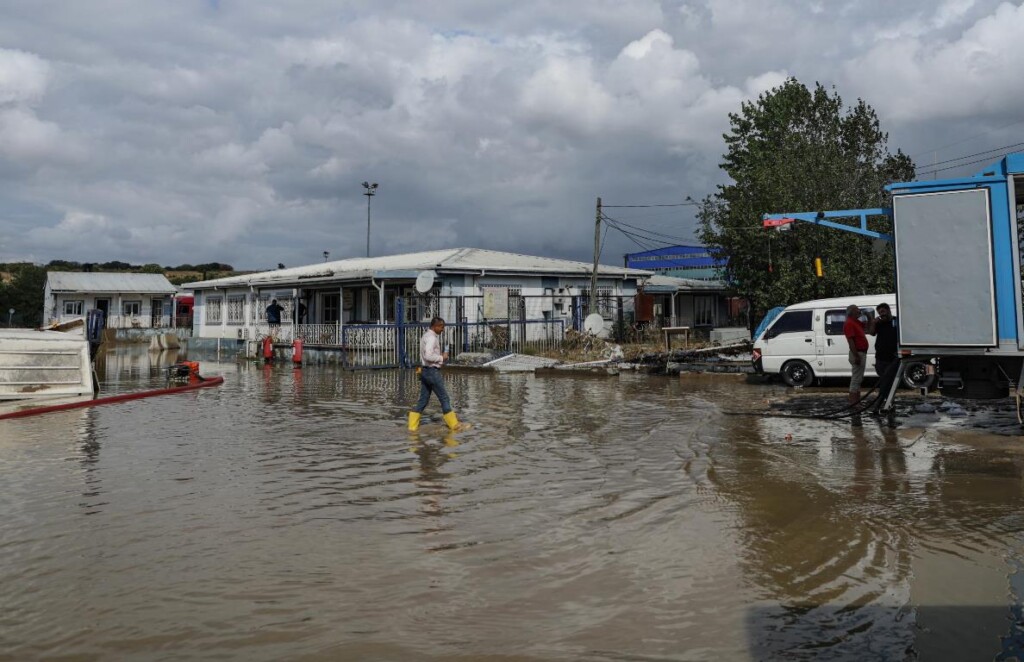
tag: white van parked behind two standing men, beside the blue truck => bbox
[754,294,928,386]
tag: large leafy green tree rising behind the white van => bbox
[697,78,914,324]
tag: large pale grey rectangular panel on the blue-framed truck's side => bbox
[893,189,996,347]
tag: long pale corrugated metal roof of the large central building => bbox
[183,248,651,289]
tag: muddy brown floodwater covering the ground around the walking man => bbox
[0,349,1024,662]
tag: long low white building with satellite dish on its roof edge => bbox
[184,248,651,338]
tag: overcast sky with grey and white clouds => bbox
[0,0,1024,268]
